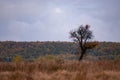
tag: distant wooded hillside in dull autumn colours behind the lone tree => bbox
[0,41,120,61]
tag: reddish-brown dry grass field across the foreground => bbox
[0,59,120,80]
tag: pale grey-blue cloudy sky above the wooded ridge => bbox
[0,0,120,42]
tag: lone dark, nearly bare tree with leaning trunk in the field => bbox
[70,25,98,61]
